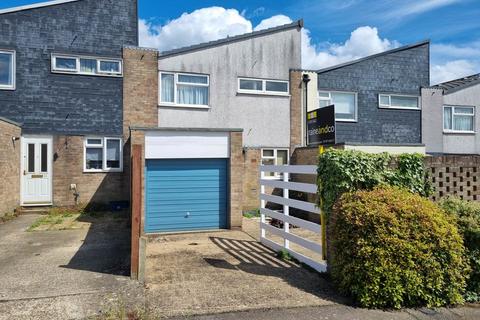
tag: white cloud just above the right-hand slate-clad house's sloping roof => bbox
[302,26,399,69]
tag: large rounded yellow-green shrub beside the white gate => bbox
[329,187,468,308]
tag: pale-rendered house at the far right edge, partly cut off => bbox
[422,74,480,155]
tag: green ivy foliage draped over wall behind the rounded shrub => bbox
[317,149,433,214]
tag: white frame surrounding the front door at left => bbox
[20,135,53,207]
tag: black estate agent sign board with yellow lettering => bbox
[307,104,336,145]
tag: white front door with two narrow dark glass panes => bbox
[21,137,52,206]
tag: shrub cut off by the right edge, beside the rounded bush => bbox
[440,197,480,302]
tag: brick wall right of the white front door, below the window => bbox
[53,136,129,206]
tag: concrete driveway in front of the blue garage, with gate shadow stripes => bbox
[145,221,339,317]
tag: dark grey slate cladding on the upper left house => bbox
[0,0,138,135]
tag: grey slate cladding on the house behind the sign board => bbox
[318,42,430,144]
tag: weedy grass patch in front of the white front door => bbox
[27,206,125,232]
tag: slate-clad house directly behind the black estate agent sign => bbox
[290,41,430,153]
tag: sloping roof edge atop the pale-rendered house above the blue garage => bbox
[160,19,303,58]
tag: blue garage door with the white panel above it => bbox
[143,130,242,234]
